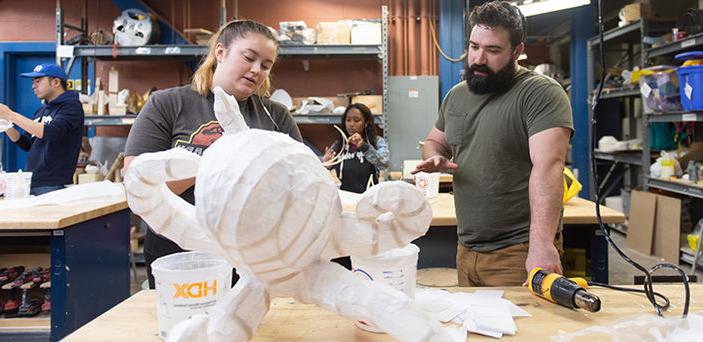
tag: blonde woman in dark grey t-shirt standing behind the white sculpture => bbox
[125,20,302,288]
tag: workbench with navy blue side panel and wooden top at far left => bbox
[0,198,130,341]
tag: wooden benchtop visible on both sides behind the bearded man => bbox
[428,193,625,227]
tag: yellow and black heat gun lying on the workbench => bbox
[528,267,600,312]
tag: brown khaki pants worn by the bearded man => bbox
[456,232,564,286]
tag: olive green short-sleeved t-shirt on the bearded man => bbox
[435,68,573,251]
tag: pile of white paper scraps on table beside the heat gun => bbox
[415,288,530,338]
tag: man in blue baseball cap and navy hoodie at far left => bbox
[0,64,84,195]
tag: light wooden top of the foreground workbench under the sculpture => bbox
[65,284,703,342]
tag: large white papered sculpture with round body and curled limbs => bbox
[125,88,451,341]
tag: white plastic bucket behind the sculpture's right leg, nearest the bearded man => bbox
[351,243,420,332]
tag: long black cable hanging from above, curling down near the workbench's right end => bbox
[589,0,691,317]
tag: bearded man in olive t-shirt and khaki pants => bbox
[413,1,574,286]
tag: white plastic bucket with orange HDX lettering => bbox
[151,252,232,338]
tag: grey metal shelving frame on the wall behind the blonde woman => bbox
[56,6,388,128]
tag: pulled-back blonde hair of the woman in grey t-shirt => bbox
[191,20,278,96]
